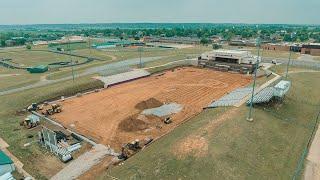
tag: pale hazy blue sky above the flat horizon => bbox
[0,0,320,25]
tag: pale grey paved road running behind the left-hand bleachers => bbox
[0,57,163,96]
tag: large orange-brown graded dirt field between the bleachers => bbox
[53,68,251,150]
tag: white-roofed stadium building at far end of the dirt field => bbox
[198,50,261,74]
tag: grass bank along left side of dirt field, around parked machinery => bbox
[0,76,103,179]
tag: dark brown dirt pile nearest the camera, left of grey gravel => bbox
[118,115,148,132]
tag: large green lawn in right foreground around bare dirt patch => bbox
[100,73,320,179]
